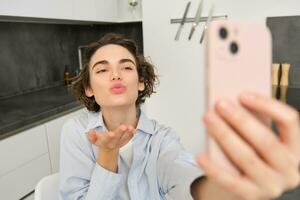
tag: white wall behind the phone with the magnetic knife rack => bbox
[143,0,300,153]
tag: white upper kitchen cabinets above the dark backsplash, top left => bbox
[0,0,142,22]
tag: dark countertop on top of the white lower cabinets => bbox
[0,86,83,140]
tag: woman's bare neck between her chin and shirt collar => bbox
[101,105,138,131]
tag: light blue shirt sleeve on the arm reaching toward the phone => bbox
[158,129,203,200]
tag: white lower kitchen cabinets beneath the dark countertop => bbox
[0,109,84,200]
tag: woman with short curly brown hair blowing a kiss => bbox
[59,34,300,200]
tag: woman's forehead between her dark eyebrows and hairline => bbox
[91,44,135,64]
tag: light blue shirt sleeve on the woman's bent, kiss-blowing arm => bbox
[59,120,122,200]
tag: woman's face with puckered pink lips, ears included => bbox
[85,44,145,109]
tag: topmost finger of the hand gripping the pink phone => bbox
[240,92,300,157]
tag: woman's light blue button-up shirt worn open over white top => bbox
[59,111,202,200]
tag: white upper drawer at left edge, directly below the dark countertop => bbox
[0,125,48,178]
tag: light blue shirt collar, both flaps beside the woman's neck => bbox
[85,108,154,135]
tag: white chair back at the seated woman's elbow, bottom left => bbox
[34,173,59,200]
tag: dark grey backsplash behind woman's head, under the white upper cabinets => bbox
[0,22,143,99]
